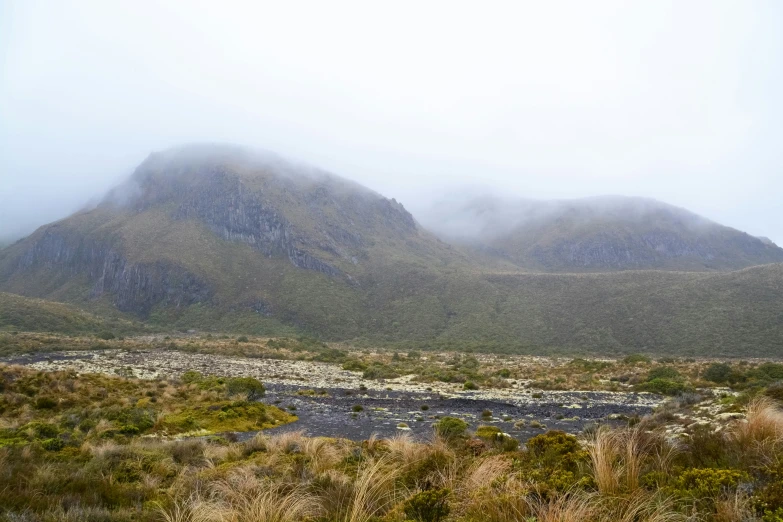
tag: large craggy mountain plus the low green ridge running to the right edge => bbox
[0,142,783,356]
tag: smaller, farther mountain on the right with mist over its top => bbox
[428,193,783,272]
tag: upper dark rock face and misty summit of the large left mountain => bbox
[119,146,416,280]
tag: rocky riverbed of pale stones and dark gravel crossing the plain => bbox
[3,350,663,440]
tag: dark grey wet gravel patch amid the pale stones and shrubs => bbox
[264,384,652,441]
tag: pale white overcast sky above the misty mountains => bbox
[0,0,783,244]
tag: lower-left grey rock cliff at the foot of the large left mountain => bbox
[18,229,211,317]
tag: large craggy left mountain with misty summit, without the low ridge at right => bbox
[0,146,478,337]
